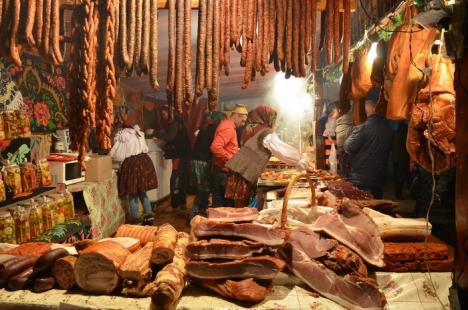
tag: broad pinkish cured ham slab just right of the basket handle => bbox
[313,201,384,267]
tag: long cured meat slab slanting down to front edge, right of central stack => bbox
[278,226,386,309]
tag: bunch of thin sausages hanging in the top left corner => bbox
[0,0,63,66]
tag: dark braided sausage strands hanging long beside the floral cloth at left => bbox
[68,0,119,167]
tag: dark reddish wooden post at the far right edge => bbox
[455,52,468,290]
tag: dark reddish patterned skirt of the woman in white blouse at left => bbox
[119,153,158,196]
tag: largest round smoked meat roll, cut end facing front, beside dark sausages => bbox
[75,240,130,294]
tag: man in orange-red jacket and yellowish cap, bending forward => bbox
[210,104,248,208]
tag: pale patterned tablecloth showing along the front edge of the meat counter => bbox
[0,272,452,310]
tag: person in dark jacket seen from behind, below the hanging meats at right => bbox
[344,89,393,199]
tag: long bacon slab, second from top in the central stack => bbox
[191,215,286,246]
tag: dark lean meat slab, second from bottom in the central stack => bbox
[187,256,284,280]
